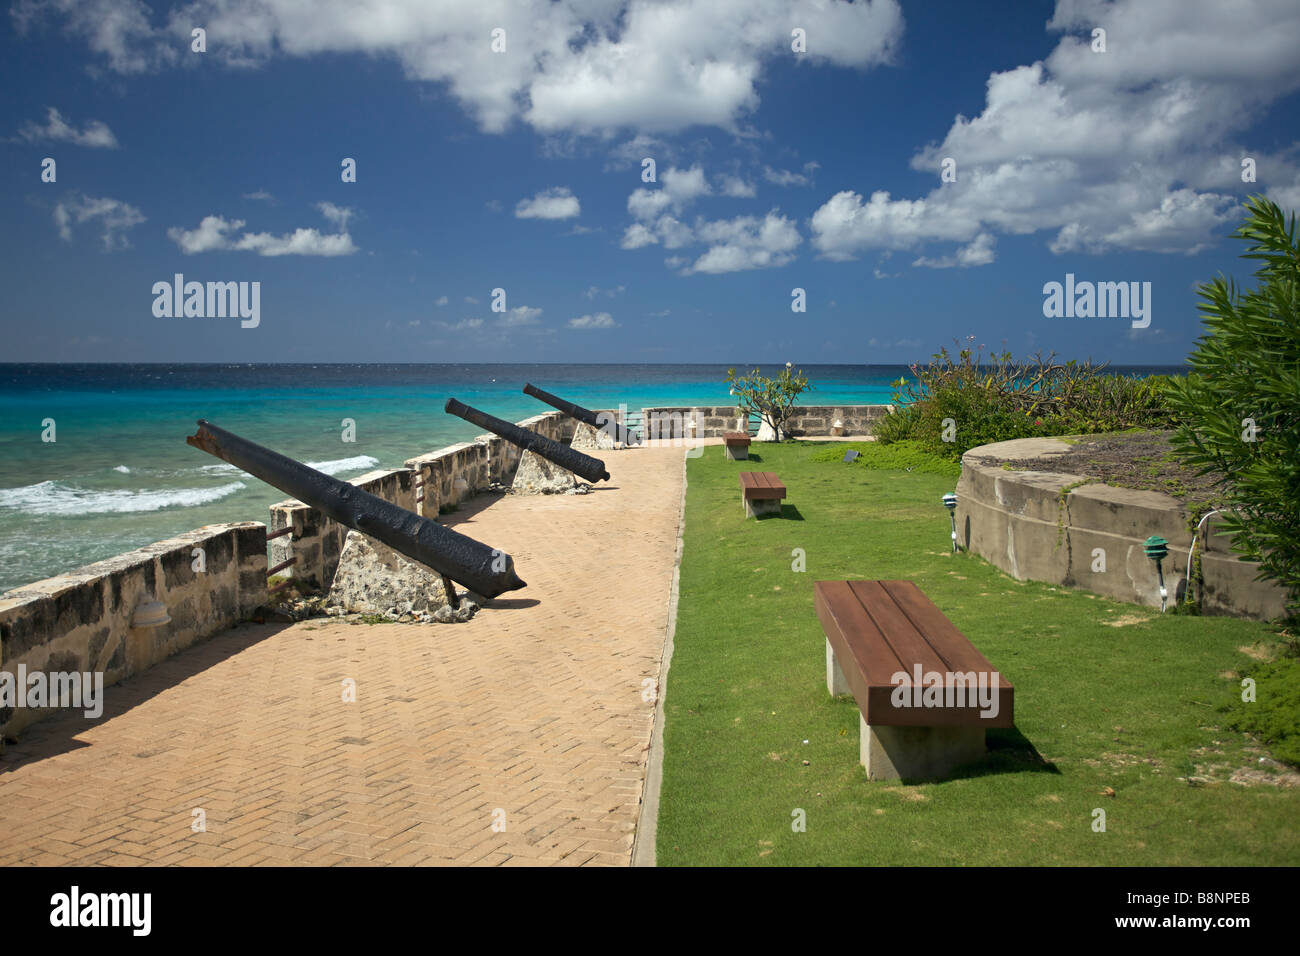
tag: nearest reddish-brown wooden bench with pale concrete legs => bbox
[813,581,1015,780]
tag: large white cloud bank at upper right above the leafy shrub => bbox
[813,0,1300,265]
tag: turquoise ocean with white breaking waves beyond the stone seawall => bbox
[0,364,1174,593]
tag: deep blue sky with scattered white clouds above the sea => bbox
[0,0,1300,364]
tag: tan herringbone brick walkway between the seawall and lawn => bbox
[0,447,683,866]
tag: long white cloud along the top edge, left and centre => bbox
[25,0,902,134]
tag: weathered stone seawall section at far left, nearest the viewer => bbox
[0,522,267,736]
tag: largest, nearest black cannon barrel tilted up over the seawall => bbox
[185,419,527,597]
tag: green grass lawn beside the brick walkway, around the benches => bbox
[657,442,1300,865]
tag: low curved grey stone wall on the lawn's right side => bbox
[956,438,1286,620]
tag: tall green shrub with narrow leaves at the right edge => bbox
[1166,196,1300,614]
